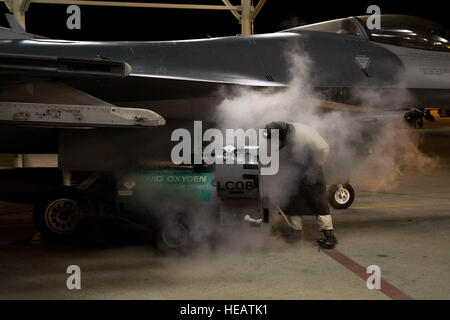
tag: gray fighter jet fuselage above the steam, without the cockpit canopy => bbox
[0,18,450,117]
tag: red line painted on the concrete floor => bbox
[322,249,414,300]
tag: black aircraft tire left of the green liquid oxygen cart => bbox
[33,187,92,242]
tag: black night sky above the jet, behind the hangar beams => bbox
[0,0,449,40]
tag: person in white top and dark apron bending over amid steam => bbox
[265,122,337,249]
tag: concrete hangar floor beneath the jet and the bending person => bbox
[0,129,450,299]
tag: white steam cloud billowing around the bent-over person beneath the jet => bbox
[217,48,437,200]
